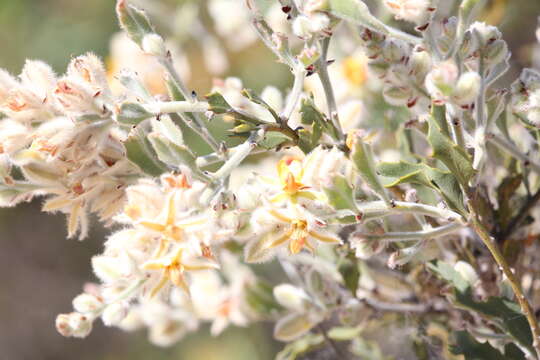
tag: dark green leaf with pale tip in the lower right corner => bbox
[428,261,533,351]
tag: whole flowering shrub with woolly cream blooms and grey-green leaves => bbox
[0,0,540,359]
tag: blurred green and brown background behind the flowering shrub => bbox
[0,0,540,360]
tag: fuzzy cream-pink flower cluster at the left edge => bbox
[0,54,138,238]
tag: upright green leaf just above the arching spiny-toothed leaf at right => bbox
[428,110,475,187]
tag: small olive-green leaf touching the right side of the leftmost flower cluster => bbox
[124,127,167,176]
